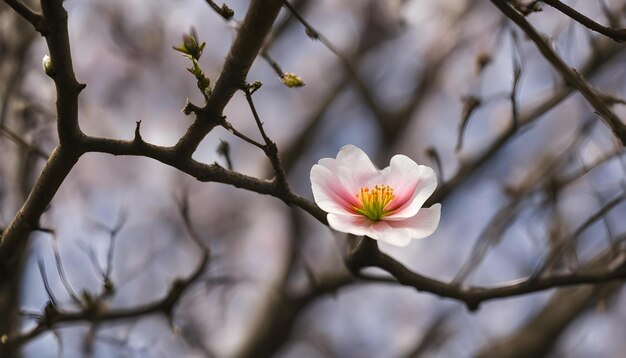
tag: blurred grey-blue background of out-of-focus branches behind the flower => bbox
[0,0,626,357]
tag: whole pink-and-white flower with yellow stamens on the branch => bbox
[311,145,441,246]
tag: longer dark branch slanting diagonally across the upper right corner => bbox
[491,0,626,146]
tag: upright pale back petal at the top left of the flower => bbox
[335,145,380,194]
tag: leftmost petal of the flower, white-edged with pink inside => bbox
[311,160,358,215]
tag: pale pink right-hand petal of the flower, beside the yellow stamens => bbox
[383,155,437,220]
